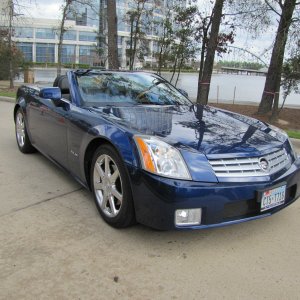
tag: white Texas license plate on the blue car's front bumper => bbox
[260,185,286,211]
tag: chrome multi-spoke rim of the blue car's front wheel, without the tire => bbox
[93,154,123,218]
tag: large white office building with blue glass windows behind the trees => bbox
[0,0,187,68]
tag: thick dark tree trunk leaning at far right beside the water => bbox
[258,0,300,115]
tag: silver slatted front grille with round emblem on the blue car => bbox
[209,149,290,177]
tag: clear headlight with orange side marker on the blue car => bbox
[134,136,191,180]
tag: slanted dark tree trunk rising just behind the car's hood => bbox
[197,0,225,104]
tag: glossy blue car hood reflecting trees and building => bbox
[90,105,285,157]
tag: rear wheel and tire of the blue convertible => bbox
[15,108,36,153]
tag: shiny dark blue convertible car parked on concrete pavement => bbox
[14,70,300,230]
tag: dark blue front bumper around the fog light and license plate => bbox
[129,160,300,230]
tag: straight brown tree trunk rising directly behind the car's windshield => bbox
[107,0,119,69]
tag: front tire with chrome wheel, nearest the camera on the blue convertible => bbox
[90,144,135,228]
